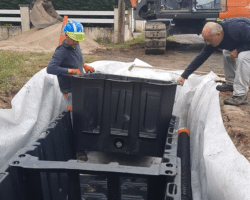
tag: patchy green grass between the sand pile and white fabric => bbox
[0,51,101,93]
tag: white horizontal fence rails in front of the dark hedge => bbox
[0,9,127,24]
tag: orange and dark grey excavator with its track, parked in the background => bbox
[130,0,250,54]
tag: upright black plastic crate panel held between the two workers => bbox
[72,74,176,157]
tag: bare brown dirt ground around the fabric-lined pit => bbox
[0,35,250,161]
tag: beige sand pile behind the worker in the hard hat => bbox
[0,23,102,54]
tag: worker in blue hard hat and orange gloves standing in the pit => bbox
[47,21,94,161]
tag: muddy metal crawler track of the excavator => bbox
[145,22,167,54]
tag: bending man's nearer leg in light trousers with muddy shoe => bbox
[224,51,250,105]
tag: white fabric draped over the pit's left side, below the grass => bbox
[0,69,66,168]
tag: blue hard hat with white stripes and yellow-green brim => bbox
[63,20,84,41]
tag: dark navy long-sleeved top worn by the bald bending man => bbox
[181,17,250,79]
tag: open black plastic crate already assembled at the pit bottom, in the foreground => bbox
[0,111,181,200]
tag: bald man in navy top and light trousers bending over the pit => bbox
[177,17,250,105]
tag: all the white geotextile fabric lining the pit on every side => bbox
[0,59,250,200]
